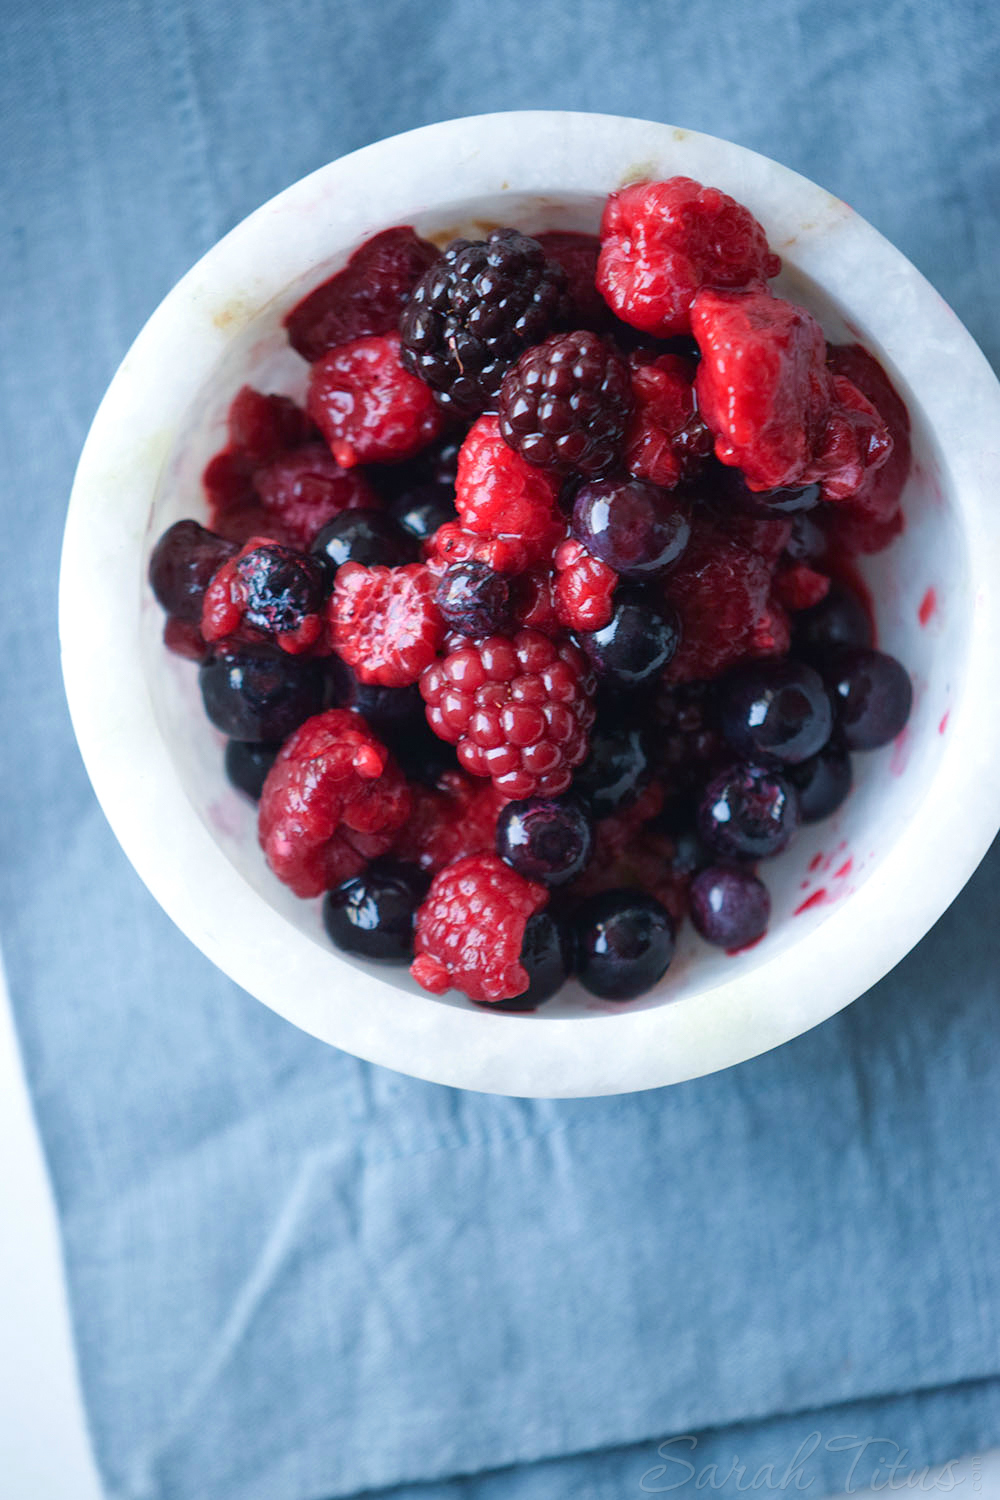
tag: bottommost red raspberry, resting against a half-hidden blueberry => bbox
[409,854,549,1001]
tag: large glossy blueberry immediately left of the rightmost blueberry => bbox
[717,659,834,765]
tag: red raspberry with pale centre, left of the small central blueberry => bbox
[330,563,444,687]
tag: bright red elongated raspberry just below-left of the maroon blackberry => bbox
[454,416,565,566]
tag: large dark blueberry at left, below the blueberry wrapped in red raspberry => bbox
[198,644,327,743]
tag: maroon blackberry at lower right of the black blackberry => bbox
[499,330,633,477]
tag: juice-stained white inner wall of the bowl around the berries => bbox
[135,192,973,1025]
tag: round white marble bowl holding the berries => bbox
[60,113,1000,1097]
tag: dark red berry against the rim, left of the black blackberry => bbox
[285,225,438,362]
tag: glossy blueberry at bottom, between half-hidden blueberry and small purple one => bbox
[576,890,675,1001]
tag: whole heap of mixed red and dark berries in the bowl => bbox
[150,177,912,1011]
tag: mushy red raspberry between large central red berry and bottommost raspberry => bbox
[393,771,505,875]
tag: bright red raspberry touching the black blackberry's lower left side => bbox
[306,333,444,468]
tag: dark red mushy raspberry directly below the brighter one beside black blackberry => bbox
[253,443,379,552]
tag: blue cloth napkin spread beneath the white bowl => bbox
[0,0,1000,1500]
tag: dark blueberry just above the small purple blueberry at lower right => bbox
[699,764,799,860]
